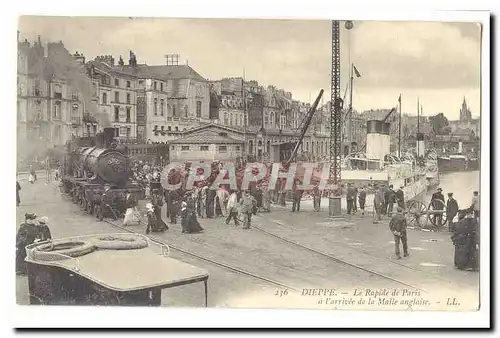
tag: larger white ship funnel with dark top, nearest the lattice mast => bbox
[366,120,391,160]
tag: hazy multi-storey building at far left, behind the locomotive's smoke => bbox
[17,38,92,163]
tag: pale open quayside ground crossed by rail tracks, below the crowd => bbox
[17,178,479,307]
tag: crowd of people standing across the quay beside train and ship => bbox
[16,161,480,273]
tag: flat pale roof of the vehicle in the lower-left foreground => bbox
[27,234,208,292]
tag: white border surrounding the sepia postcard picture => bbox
[1,0,490,328]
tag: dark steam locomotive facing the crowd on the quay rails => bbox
[60,128,143,218]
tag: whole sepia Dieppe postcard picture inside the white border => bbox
[15,9,490,328]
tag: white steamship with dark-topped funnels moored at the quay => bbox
[342,120,439,200]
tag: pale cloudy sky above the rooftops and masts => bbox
[19,16,481,120]
